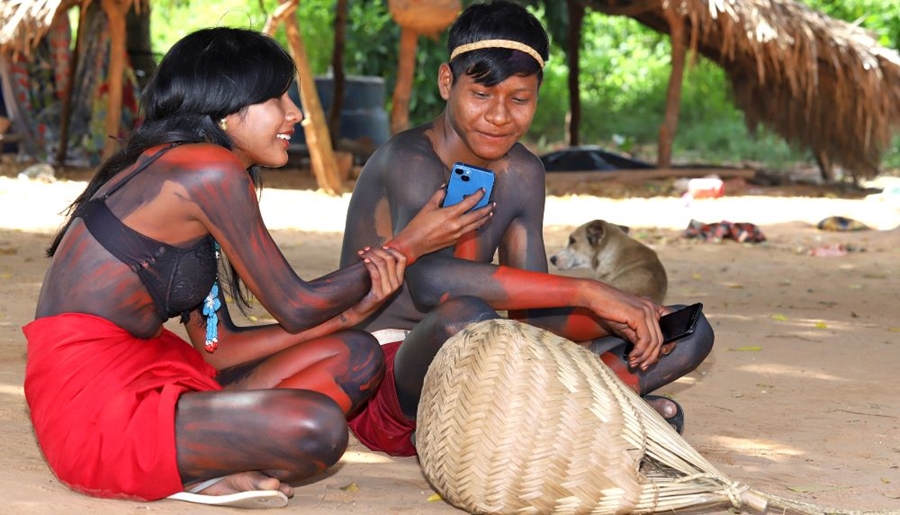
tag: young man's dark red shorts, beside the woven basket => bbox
[349,342,416,456]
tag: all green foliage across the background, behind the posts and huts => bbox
[144,0,900,173]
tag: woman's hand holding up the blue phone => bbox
[385,188,494,265]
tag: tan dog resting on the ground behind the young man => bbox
[550,220,668,304]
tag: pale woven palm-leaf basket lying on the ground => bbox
[416,320,872,515]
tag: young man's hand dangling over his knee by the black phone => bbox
[588,282,671,370]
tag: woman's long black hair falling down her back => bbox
[47,27,297,314]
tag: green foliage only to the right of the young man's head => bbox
[528,0,900,168]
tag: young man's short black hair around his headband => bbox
[447,0,550,87]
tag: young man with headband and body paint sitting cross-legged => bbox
[341,1,713,455]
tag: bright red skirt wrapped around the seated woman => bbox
[23,313,222,500]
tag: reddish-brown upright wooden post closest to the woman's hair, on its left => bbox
[101,0,131,159]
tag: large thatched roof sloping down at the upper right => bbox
[585,0,900,177]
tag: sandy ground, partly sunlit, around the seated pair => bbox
[0,167,900,515]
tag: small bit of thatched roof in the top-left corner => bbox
[0,0,71,54]
